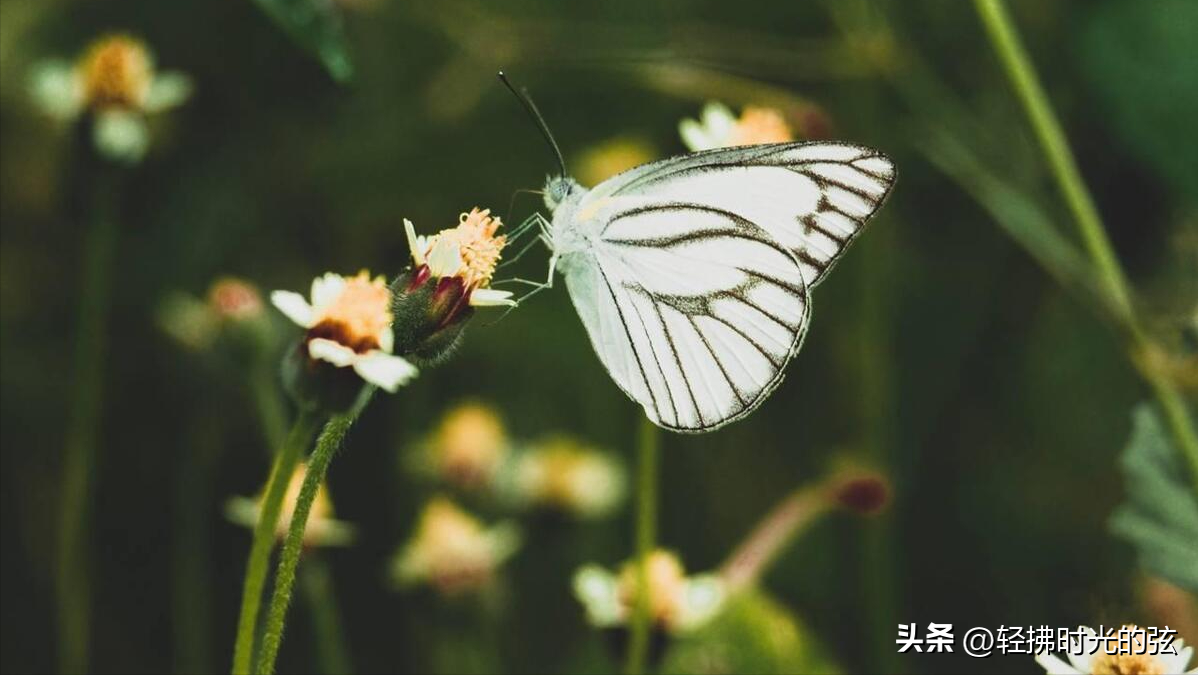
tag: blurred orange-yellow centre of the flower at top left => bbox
[79,35,153,108]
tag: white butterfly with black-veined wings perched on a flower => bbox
[522,143,895,432]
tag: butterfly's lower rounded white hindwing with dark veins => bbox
[561,203,810,432]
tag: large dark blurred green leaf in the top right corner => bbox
[1079,0,1198,199]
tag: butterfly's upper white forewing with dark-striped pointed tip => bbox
[583,143,895,288]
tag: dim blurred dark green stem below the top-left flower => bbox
[55,166,119,673]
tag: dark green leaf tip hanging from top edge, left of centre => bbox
[254,0,353,83]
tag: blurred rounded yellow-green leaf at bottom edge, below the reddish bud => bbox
[660,589,840,675]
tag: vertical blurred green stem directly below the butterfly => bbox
[624,416,659,675]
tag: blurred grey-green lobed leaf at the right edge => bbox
[1111,403,1198,591]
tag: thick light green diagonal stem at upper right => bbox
[974,0,1198,487]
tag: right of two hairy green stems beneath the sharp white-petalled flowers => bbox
[254,405,363,675]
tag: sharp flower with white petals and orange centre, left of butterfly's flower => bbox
[271,270,417,392]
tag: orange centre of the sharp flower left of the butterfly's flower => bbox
[308,270,392,354]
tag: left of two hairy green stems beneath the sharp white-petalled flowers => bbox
[232,410,322,675]
